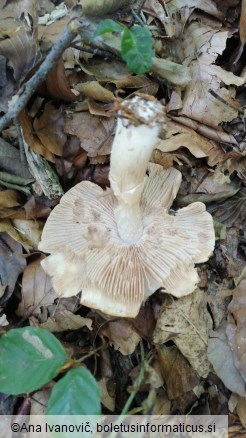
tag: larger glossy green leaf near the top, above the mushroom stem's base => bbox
[121,24,155,74]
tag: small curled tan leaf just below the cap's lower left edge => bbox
[30,308,92,333]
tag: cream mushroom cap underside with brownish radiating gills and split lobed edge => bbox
[39,163,215,317]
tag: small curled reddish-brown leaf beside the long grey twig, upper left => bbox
[46,58,77,102]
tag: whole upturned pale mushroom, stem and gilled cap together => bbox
[39,95,215,317]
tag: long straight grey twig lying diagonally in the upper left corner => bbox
[0,19,80,132]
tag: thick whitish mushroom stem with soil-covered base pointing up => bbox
[109,95,164,243]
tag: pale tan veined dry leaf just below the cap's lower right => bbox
[154,289,212,377]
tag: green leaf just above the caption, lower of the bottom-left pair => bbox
[46,367,101,415]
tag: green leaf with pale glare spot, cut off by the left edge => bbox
[0,327,67,394]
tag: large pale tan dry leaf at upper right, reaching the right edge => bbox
[178,14,245,127]
